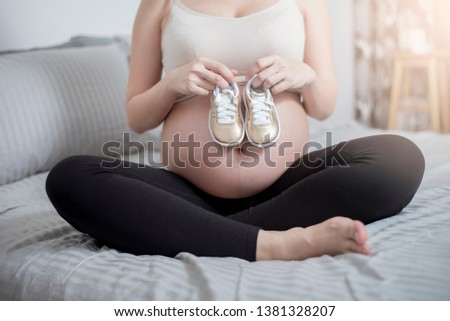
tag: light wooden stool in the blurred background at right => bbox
[388,53,450,131]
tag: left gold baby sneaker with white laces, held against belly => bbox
[208,83,245,147]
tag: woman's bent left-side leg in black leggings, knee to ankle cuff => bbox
[46,156,258,260]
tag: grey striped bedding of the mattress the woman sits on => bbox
[0,121,450,300]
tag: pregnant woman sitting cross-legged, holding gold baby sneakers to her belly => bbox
[46,0,424,261]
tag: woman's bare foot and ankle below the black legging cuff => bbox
[256,217,370,260]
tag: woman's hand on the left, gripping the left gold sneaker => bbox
[167,58,237,96]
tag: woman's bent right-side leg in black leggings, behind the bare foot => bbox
[239,135,425,229]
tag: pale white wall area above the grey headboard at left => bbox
[0,0,140,51]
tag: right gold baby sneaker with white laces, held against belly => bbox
[244,76,280,148]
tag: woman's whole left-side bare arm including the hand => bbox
[126,0,237,133]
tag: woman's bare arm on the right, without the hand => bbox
[297,0,337,120]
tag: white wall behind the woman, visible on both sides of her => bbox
[0,0,354,118]
